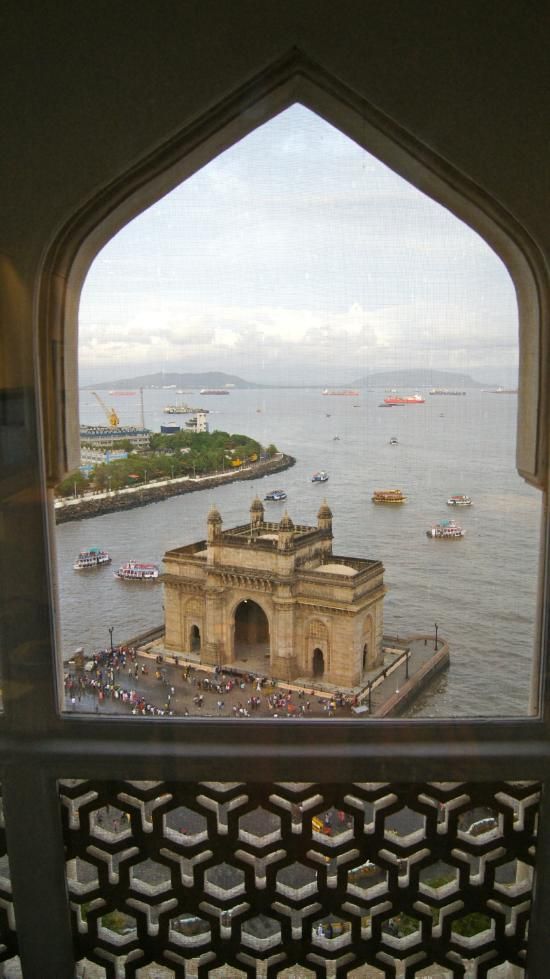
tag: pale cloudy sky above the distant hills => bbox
[79,105,518,384]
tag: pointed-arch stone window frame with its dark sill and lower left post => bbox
[0,52,550,979]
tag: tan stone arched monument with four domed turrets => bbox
[162,497,385,689]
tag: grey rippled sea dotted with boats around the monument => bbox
[56,388,542,718]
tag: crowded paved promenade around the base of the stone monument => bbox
[66,629,449,722]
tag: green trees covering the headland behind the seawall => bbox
[55,431,278,497]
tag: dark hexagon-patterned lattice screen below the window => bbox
[60,780,539,979]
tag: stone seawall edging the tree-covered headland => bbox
[55,455,296,523]
